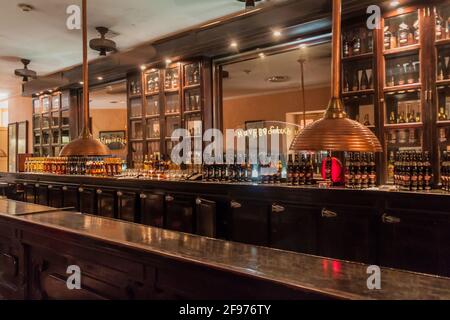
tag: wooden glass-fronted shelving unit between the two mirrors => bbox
[128,58,212,168]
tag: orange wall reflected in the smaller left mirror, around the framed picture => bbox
[90,109,127,159]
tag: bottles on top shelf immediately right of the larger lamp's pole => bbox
[342,28,373,57]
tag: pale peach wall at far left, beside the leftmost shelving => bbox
[8,97,33,153]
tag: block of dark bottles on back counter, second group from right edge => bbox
[388,151,433,191]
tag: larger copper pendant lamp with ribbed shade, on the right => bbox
[290,0,382,152]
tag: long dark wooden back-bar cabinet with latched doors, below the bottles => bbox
[5,174,450,276]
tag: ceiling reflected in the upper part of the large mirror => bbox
[223,43,331,98]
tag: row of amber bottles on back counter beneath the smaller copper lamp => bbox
[25,157,126,177]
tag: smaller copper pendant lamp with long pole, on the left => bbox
[59,0,110,157]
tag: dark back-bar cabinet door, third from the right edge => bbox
[270,203,320,254]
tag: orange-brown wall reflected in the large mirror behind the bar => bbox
[223,87,330,129]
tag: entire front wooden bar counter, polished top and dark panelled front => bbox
[0,200,450,299]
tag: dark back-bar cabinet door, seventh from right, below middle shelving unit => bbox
[140,192,165,228]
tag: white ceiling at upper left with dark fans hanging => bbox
[0,0,258,100]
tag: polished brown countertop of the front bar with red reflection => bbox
[0,202,450,299]
